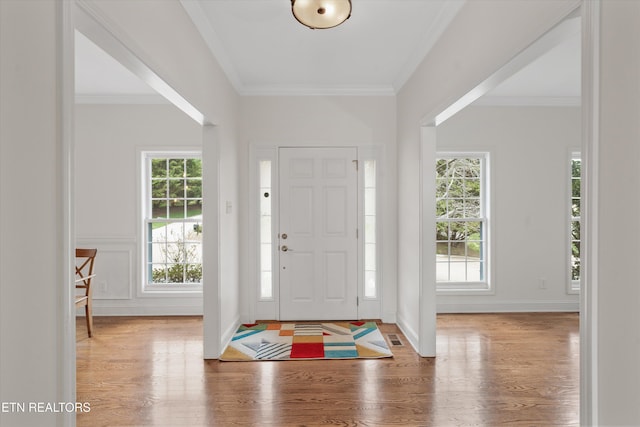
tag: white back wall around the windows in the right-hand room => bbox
[437,107,581,312]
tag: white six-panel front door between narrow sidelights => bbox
[279,148,358,320]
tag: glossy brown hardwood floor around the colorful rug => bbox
[77,313,579,427]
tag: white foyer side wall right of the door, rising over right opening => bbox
[397,0,579,354]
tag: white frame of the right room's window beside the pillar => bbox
[433,151,495,295]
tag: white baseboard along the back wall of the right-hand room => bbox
[436,301,580,313]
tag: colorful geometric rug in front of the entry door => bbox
[220,322,393,361]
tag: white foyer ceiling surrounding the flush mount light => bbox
[181,0,463,95]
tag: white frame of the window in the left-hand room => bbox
[139,148,203,297]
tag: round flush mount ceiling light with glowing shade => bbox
[291,0,351,29]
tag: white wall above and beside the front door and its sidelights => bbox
[240,96,397,322]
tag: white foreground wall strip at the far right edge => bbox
[589,0,640,426]
